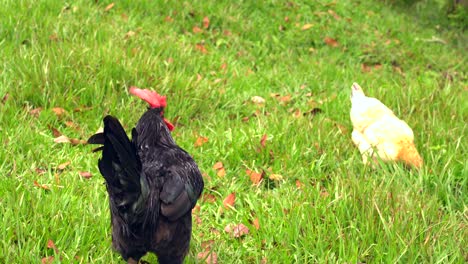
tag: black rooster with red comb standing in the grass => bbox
[88,87,203,263]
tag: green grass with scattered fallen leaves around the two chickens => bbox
[0,0,468,263]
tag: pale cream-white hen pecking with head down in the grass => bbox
[350,83,423,168]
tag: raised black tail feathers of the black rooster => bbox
[88,116,149,225]
